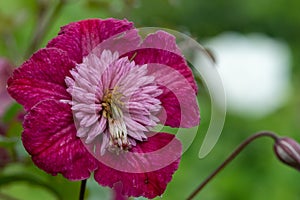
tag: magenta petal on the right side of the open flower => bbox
[128,49,200,128]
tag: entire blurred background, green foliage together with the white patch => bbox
[0,0,300,200]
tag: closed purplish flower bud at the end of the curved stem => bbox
[274,137,300,170]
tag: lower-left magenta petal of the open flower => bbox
[22,100,97,180]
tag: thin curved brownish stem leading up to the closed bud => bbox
[187,131,279,200]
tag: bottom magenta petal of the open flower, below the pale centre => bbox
[95,133,181,198]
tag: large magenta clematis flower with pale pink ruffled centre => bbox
[8,19,200,198]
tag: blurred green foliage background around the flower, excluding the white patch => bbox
[0,0,300,200]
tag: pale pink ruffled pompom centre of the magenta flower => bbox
[65,50,162,154]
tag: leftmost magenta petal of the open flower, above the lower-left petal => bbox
[7,48,75,110]
